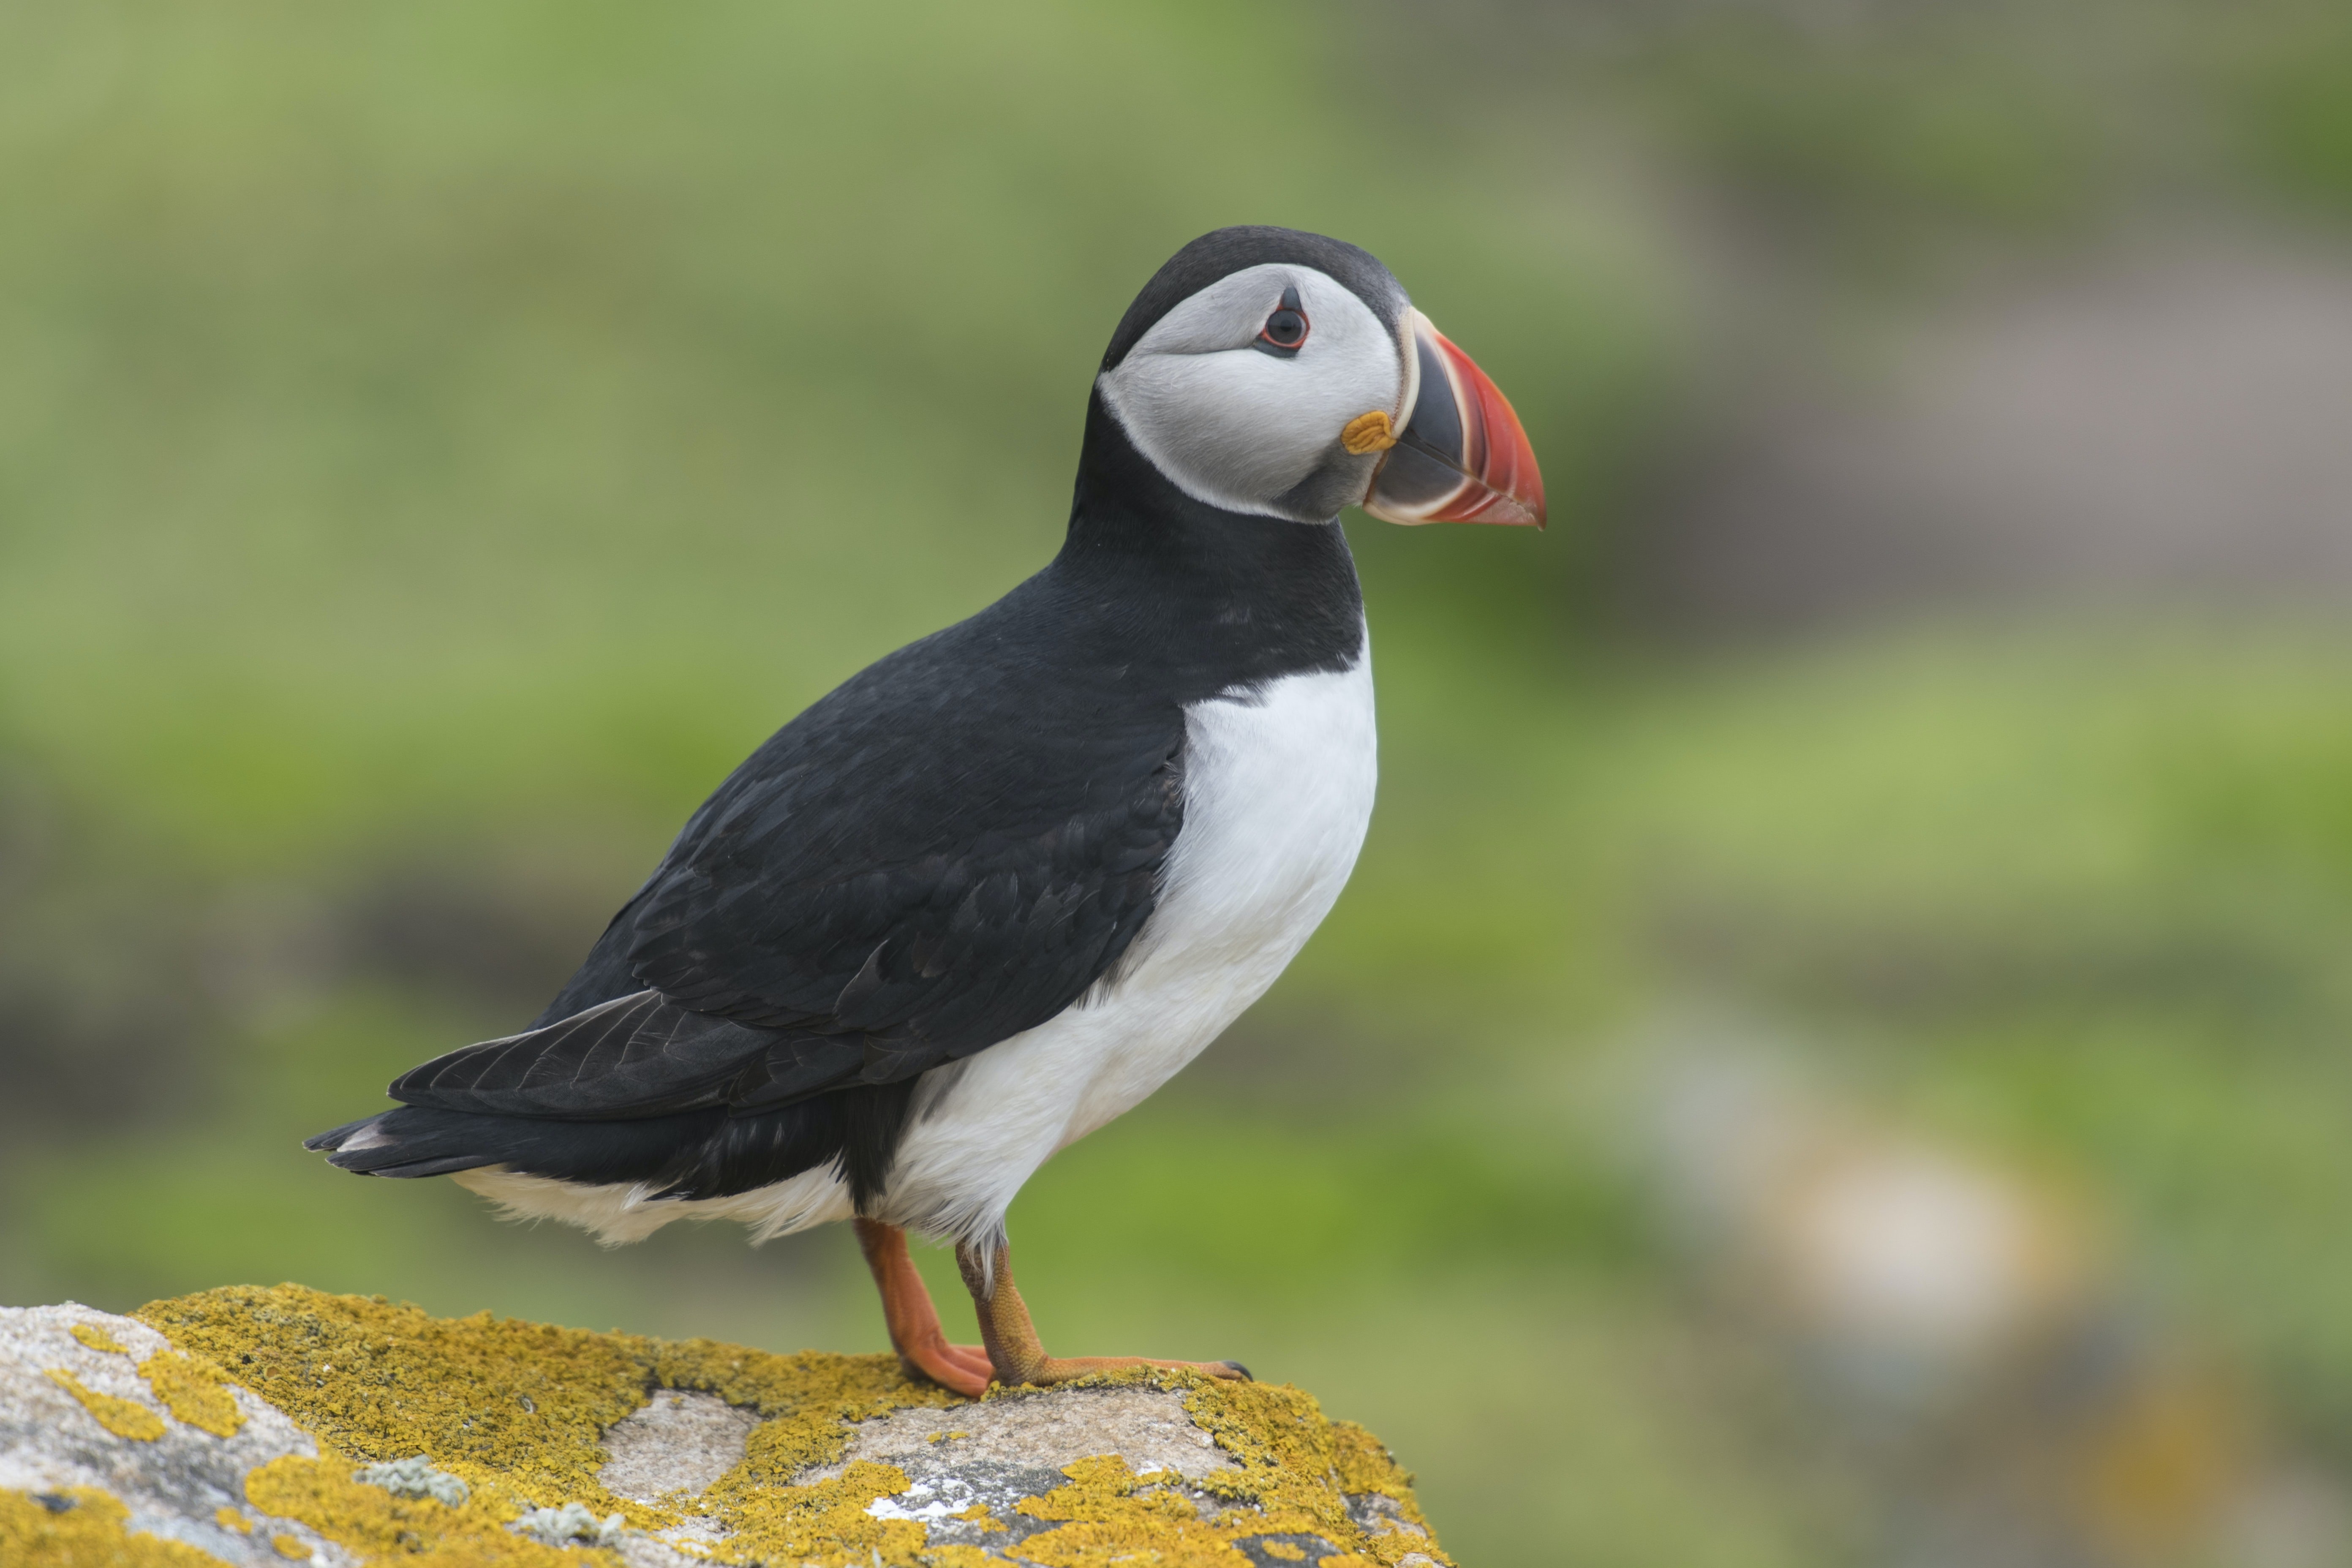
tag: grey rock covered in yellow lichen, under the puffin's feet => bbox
[0,1286,1451,1568]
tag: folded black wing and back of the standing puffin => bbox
[390,595,1183,1119]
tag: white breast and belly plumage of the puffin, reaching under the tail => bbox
[456,642,1378,1246]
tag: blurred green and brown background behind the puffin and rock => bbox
[0,0,2352,1568]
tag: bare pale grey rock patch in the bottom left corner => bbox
[0,1302,353,1568]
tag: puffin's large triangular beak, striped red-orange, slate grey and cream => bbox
[1343,310,1543,529]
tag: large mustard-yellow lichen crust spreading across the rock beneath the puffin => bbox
[139,1286,1451,1568]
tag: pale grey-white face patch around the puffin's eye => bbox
[1096,263,1413,522]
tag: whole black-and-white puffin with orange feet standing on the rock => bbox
[303,226,1543,1396]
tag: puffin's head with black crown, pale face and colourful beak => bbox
[1094,226,1543,529]
